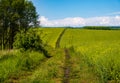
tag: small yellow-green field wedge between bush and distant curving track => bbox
[37,28,64,48]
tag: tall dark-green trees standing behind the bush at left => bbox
[0,0,39,49]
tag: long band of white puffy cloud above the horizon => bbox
[39,16,120,27]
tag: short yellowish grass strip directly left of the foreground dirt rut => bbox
[21,49,64,83]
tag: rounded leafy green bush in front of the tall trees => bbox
[14,29,50,58]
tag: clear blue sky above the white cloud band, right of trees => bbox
[32,0,120,26]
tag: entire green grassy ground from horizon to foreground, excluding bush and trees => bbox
[0,28,120,83]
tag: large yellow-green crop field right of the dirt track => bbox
[61,29,120,83]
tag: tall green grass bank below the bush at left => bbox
[0,51,45,82]
